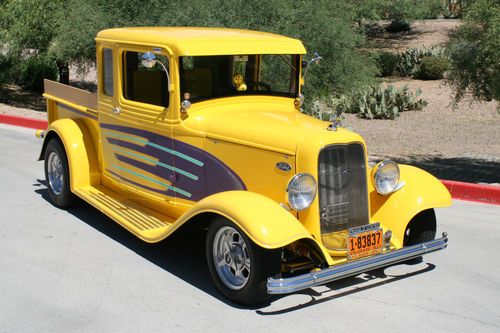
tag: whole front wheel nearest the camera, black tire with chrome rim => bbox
[206,218,281,305]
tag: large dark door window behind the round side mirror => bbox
[123,51,169,107]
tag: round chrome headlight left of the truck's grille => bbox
[286,173,316,211]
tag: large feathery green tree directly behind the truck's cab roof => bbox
[55,0,376,97]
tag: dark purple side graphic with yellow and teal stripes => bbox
[99,123,246,201]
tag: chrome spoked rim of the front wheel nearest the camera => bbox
[213,226,251,290]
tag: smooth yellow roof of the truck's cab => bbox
[96,27,306,56]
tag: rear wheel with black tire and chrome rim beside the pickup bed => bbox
[44,139,77,208]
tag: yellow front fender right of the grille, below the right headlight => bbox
[369,165,451,248]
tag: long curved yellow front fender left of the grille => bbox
[177,191,331,261]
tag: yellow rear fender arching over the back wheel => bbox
[40,118,100,191]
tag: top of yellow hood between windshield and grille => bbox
[184,96,328,155]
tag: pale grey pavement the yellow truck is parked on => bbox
[0,125,500,332]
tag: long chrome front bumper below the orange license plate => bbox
[267,232,448,294]
